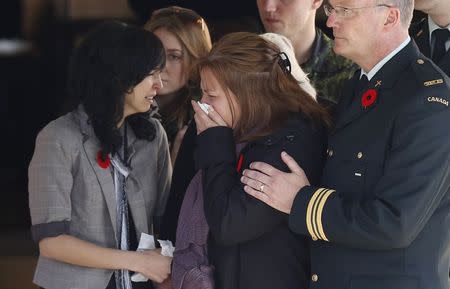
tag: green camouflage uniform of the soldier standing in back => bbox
[301,28,357,106]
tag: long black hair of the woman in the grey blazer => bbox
[68,22,165,157]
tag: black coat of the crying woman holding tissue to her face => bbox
[196,116,326,289]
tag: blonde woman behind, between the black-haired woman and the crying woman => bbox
[144,6,211,164]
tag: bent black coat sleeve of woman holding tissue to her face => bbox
[195,120,324,245]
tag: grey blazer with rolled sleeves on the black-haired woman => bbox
[28,106,172,289]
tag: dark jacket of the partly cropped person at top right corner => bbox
[409,18,450,76]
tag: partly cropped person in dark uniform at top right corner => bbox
[410,0,450,76]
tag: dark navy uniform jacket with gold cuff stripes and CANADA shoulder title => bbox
[289,42,450,289]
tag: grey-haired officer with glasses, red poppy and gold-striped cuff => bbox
[242,0,450,289]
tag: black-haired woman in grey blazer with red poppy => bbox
[29,22,171,289]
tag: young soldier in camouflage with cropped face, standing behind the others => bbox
[256,0,356,107]
